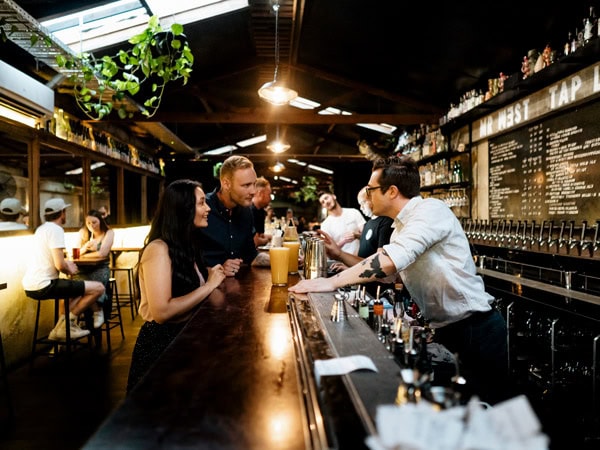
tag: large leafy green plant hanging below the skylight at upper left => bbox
[56,16,194,120]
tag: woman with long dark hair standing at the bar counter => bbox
[127,180,225,393]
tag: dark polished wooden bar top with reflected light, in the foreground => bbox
[84,267,312,450]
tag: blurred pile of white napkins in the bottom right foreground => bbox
[365,395,550,450]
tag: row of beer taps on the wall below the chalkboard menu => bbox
[462,219,600,257]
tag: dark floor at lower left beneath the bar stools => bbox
[0,309,143,450]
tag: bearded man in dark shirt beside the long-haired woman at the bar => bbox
[197,155,258,277]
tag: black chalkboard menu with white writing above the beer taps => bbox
[489,102,600,222]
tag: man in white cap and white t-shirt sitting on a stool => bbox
[22,198,105,341]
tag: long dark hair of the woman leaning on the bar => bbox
[140,179,208,297]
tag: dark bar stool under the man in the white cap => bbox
[29,297,93,370]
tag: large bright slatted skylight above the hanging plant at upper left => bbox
[40,0,248,53]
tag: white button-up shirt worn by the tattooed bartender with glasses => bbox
[383,196,494,328]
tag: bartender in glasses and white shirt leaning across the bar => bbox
[289,156,509,404]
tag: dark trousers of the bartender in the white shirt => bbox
[435,310,511,404]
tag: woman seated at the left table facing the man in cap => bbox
[74,209,115,328]
